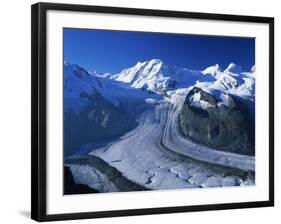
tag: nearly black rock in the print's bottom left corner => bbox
[64,166,98,194]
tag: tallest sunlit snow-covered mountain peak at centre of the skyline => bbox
[113,59,215,94]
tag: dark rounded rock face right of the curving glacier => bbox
[179,87,255,155]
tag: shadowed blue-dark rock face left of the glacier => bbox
[64,92,136,156]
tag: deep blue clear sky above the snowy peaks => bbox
[64,28,255,73]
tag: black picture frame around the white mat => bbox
[31,3,274,221]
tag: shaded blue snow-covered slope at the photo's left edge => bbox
[64,62,159,113]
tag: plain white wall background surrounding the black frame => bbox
[0,0,276,224]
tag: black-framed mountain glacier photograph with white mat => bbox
[31,3,274,221]
